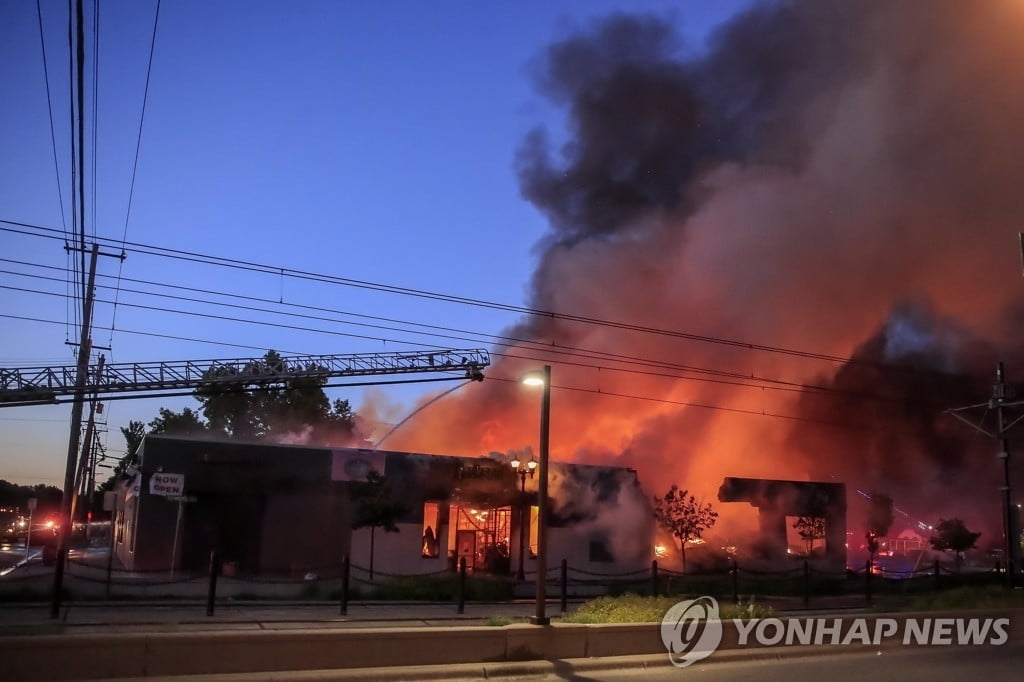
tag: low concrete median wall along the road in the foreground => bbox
[0,610,1022,680]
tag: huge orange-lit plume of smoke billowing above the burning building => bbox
[380,0,1024,540]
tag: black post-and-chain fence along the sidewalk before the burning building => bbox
[0,553,1011,614]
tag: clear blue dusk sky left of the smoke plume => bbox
[0,0,750,485]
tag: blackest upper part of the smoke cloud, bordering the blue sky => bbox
[518,2,868,244]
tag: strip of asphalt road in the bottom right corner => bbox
[565,641,1024,682]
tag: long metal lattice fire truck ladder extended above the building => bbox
[0,349,490,408]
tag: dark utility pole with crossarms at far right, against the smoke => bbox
[947,363,1024,587]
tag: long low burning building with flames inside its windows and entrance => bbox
[115,435,653,576]
